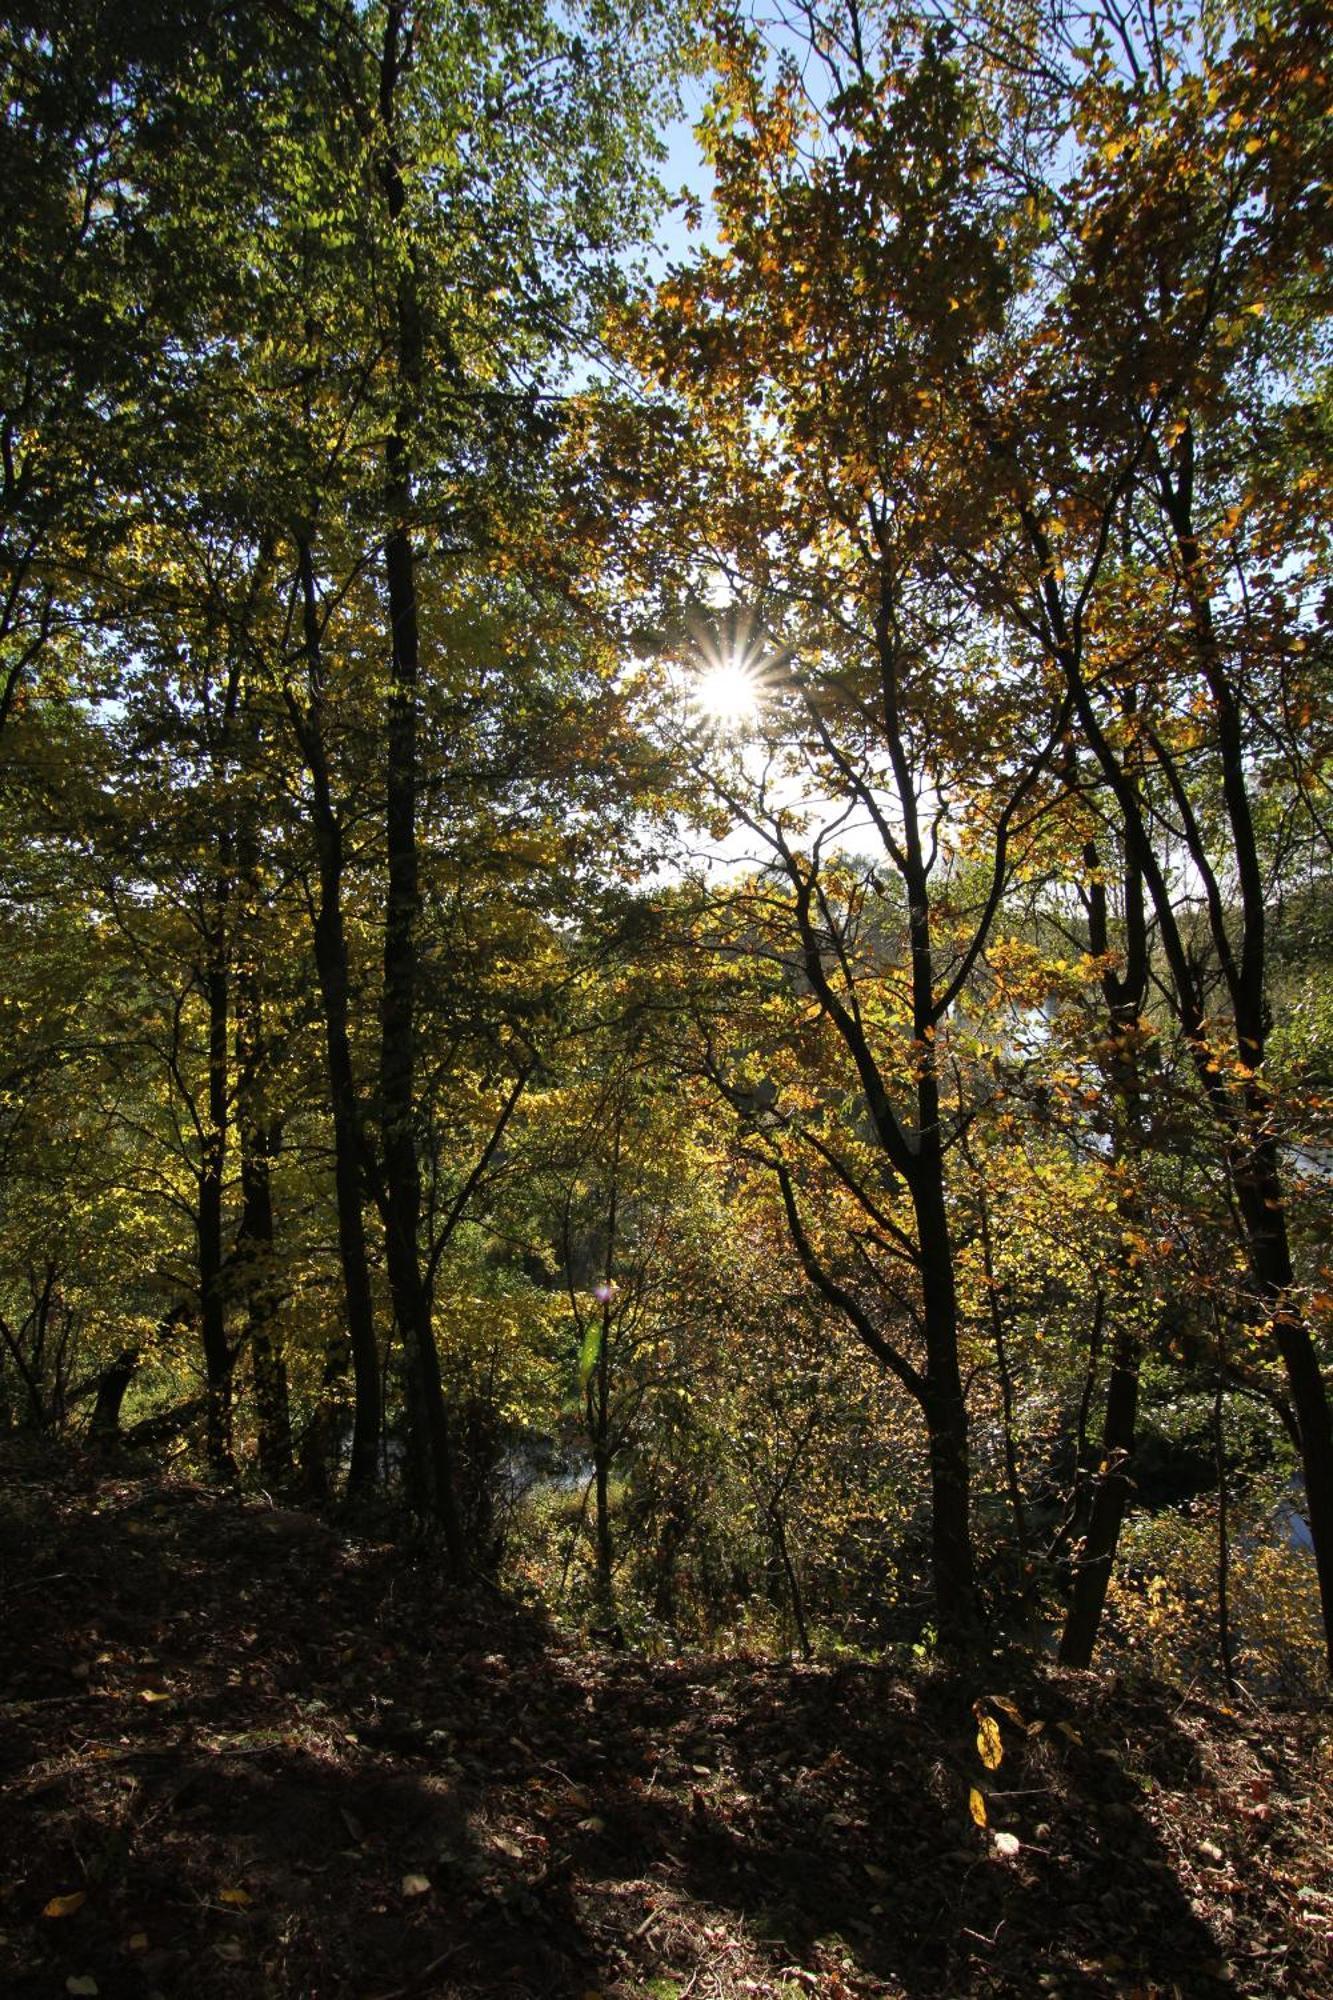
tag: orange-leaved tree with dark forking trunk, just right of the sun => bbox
[608,11,1067,1638]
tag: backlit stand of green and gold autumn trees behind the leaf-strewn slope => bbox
[0,0,1333,1704]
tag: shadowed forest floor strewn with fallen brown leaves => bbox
[0,1452,1333,2000]
